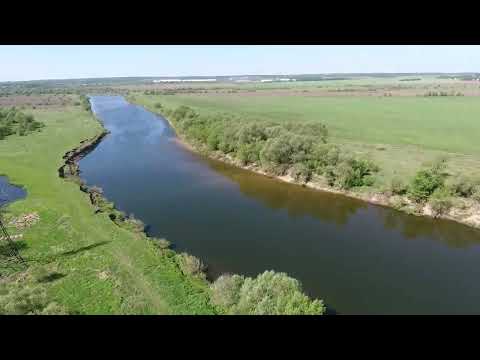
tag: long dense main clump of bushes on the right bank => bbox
[168,105,378,189]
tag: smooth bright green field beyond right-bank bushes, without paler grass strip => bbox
[134,94,480,155]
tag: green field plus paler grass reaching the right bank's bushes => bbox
[135,94,480,186]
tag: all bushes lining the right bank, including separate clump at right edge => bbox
[161,103,480,215]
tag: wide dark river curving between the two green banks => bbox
[80,96,480,314]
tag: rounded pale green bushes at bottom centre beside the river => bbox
[211,271,325,315]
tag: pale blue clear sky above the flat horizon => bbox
[0,45,480,81]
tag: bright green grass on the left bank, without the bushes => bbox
[0,107,215,314]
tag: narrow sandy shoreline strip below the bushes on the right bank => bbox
[131,99,480,229]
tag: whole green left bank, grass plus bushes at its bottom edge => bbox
[0,97,326,315]
